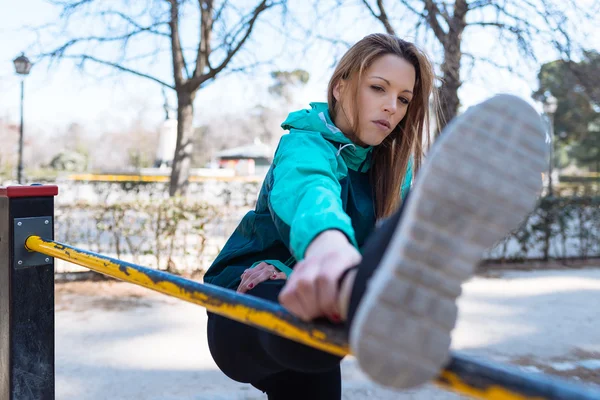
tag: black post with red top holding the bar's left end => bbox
[0,186,58,400]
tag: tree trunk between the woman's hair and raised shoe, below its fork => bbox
[436,34,462,135]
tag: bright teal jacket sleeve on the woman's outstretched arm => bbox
[269,131,358,261]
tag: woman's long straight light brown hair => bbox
[327,33,439,219]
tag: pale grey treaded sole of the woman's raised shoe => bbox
[350,95,546,389]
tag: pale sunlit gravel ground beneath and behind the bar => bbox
[56,268,600,400]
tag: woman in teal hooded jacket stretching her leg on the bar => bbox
[205,34,544,400]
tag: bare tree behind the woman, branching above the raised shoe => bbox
[360,0,599,130]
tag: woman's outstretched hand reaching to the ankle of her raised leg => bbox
[279,230,362,322]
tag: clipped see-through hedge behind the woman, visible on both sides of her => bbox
[56,196,600,273]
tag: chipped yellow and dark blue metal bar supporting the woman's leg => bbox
[25,236,600,400]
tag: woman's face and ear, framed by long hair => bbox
[333,54,416,146]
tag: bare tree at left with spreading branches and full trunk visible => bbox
[42,0,286,196]
